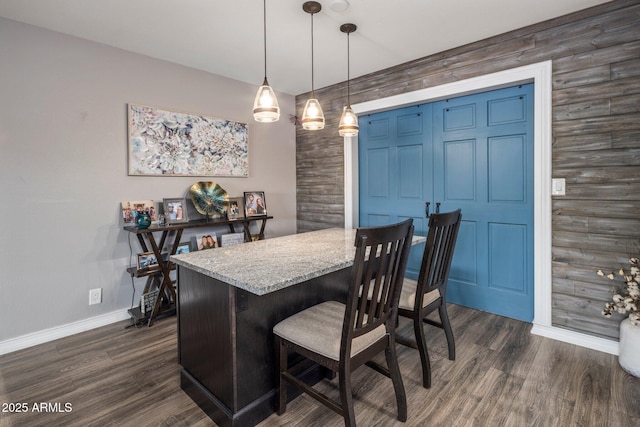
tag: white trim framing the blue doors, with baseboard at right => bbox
[344,61,618,354]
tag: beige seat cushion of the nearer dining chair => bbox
[273,301,386,360]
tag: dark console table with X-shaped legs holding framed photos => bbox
[124,216,273,326]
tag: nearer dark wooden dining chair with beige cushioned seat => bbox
[273,219,413,426]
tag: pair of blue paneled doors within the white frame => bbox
[359,84,534,322]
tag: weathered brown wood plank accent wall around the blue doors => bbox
[296,0,640,339]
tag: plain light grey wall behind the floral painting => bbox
[0,18,296,344]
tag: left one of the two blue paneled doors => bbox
[358,104,433,279]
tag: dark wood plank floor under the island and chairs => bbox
[0,305,640,427]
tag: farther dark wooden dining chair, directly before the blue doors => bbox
[396,209,462,388]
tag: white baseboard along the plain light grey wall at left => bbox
[0,309,131,355]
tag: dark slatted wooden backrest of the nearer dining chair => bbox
[341,219,413,351]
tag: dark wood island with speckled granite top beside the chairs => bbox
[171,228,424,426]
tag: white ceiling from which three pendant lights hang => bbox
[0,0,609,95]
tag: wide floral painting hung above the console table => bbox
[128,104,249,177]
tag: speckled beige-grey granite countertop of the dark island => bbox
[171,228,425,295]
